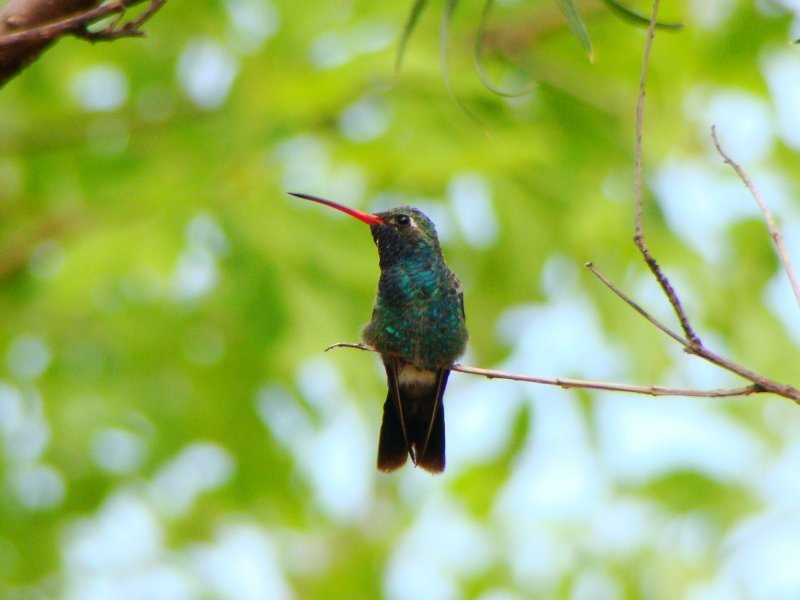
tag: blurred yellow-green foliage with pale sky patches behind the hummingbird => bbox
[0,0,800,599]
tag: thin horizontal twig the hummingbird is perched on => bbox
[325,342,766,398]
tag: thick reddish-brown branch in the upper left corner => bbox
[0,0,166,87]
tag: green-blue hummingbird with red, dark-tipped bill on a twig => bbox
[290,192,468,473]
